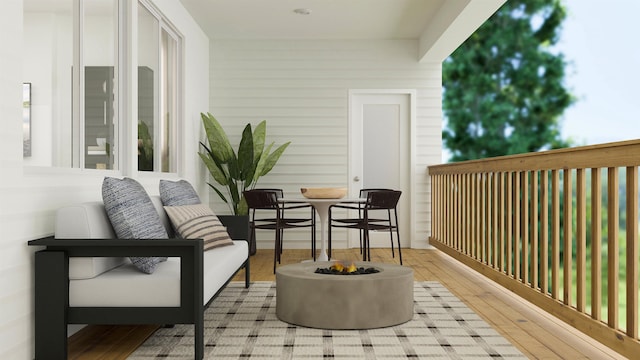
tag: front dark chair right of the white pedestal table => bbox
[328,189,402,264]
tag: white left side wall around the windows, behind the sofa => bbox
[0,0,209,360]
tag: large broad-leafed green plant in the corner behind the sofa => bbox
[198,113,291,254]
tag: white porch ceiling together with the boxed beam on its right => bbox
[180,0,507,62]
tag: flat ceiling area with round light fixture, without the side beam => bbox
[180,0,445,39]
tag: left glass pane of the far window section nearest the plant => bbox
[138,4,160,171]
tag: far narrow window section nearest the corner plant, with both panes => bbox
[138,2,179,172]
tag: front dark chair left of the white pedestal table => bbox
[244,189,316,273]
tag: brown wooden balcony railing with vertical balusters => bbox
[429,140,640,358]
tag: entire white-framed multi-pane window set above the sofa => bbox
[23,0,181,172]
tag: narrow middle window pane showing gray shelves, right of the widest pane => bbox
[82,0,118,169]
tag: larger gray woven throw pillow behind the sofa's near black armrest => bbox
[102,177,168,274]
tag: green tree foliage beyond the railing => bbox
[442,0,574,161]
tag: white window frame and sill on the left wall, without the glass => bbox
[23,0,185,177]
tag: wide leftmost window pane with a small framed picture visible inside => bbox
[22,0,78,167]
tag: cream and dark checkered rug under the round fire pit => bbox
[129,281,526,360]
